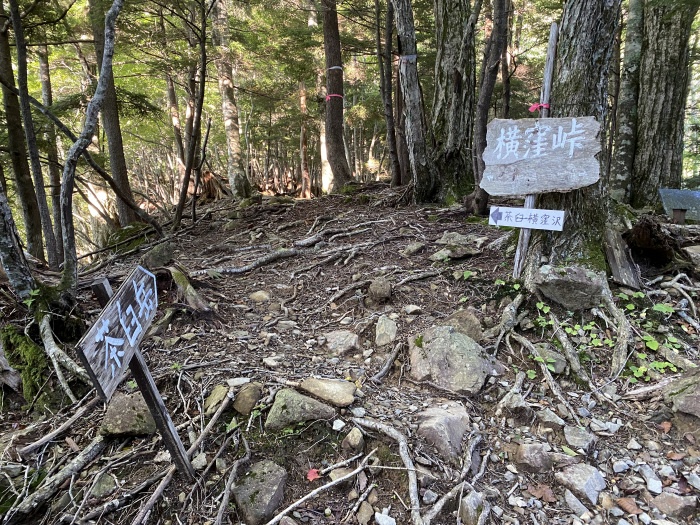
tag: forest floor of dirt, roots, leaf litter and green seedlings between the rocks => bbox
[0,181,700,525]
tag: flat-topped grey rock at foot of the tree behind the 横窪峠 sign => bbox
[534,264,607,311]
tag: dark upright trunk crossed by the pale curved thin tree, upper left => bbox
[88,0,136,226]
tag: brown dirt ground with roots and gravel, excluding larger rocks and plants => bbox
[0,186,700,525]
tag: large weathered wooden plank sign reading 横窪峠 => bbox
[481,117,600,196]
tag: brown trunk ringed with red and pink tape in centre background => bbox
[321,0,352,192]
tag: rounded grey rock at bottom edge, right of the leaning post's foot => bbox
[232,460,287,525]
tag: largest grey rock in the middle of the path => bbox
[409,326,504,394]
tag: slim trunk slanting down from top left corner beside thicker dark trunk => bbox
[9,0,58,270]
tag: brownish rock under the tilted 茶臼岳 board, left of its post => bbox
[100,392,156,436]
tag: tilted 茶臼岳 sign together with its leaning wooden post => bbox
[76,266,194,479]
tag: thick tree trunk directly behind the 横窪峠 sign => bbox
[524,0,620,286]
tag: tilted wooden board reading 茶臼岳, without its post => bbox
[76,266,158,401]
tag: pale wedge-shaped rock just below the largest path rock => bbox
[416,403,469,465]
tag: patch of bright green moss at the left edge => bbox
[0,325,49,407]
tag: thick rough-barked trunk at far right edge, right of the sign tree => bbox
[631,1,698,208]
